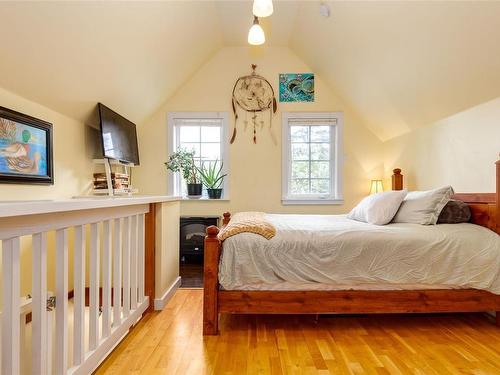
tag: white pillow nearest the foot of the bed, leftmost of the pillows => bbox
[347,190,408,225]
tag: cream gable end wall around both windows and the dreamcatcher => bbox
[134,47,383,215]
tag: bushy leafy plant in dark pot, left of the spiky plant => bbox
[165,149,203,198]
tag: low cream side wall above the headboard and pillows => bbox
[384,98,500,192]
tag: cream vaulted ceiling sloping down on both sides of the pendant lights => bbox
[0,0,500,140]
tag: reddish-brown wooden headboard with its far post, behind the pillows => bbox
[392,160,500,234]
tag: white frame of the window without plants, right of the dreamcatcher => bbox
[281,112,344,205]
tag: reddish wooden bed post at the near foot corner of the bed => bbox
[203,225,221,335]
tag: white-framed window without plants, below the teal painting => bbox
[282,112,343,204]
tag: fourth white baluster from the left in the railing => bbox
[73,225,85,366]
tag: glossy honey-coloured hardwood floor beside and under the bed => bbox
[97,289,500,375]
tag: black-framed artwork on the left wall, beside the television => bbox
[0,107,54,185]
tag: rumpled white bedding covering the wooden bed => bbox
[219,214,500,294]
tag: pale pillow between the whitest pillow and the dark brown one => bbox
[394,186,453,225]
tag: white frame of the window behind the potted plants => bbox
[167,112,229,202]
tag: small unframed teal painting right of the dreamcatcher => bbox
[279,73,314,102]
